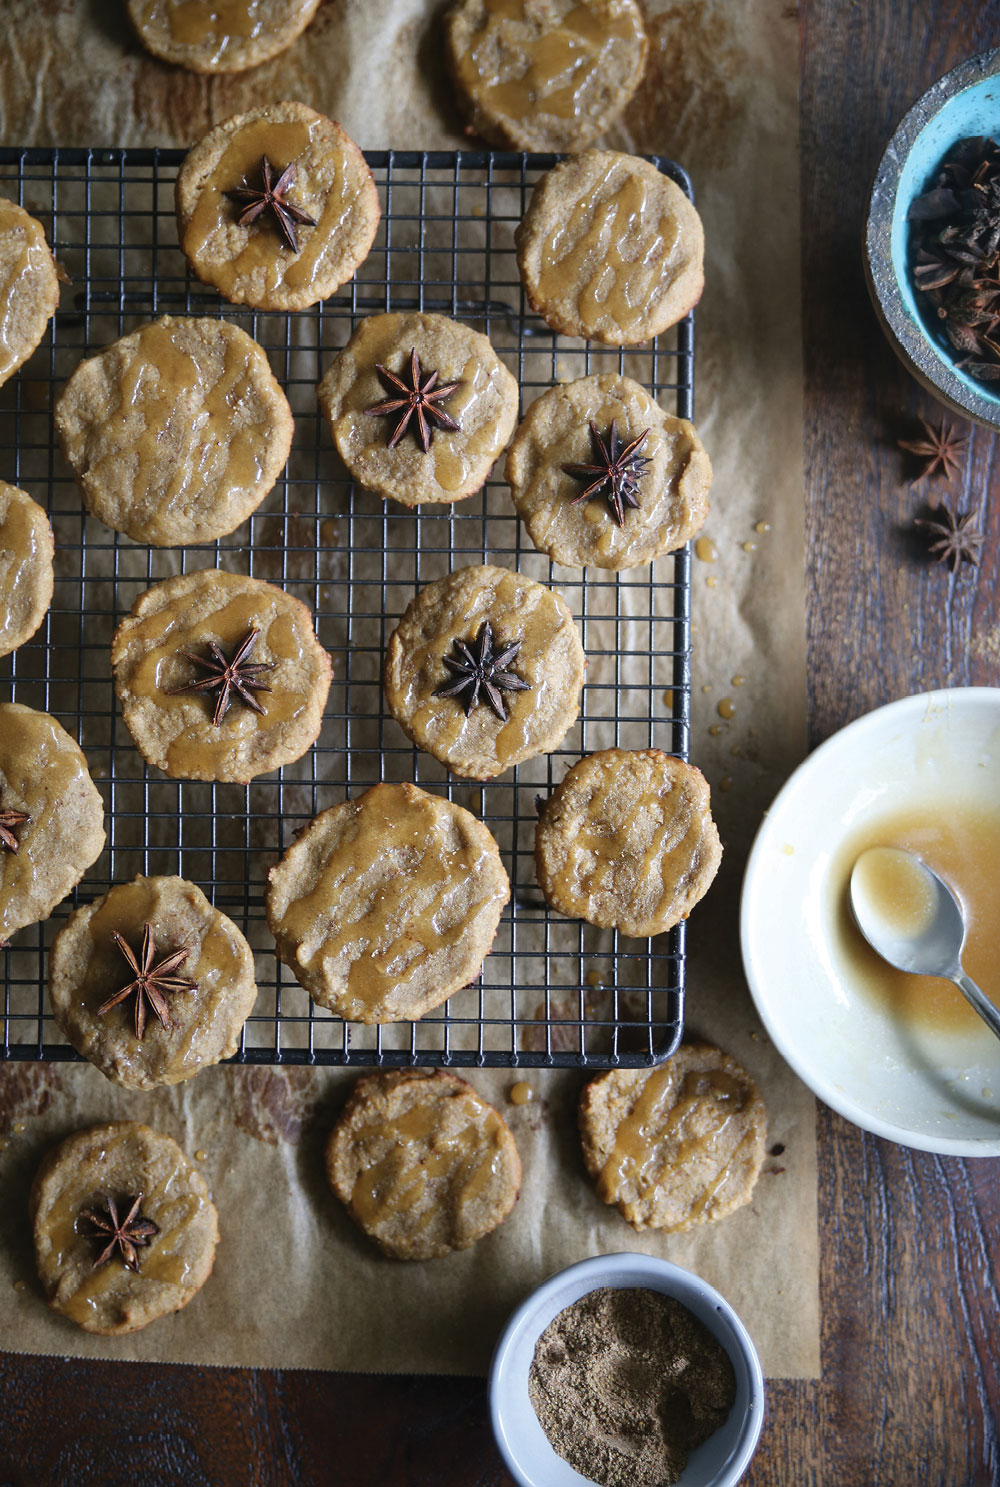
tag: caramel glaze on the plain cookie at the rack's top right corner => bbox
[539,161,679,339]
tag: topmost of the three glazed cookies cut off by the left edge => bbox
[0,196,60,384]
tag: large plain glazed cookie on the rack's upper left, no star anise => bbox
[55,315,292,547]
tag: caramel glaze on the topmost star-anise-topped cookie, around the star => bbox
[183,119,356,303]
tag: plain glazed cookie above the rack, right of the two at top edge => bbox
[445,0,649,152]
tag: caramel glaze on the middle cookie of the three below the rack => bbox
[351,1103,503,1233]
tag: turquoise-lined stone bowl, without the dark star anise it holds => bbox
[865,46,1000,428]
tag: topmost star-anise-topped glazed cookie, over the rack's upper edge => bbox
[177,103,381,311]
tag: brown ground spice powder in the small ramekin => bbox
[528,1286,737,1487]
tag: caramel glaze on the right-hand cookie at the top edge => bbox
[457,0,641,120]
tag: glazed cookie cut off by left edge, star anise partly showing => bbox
[0,702,104,943]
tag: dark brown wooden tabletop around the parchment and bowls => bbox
[0,0,1000,1487]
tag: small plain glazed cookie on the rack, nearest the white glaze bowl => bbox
[534,748,722,938]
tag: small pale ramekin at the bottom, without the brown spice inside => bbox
[490,1254,763,1487]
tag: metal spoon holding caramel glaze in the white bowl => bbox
[851,846,1000,1038]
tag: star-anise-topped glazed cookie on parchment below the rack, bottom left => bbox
[28,1121,219,1337]
